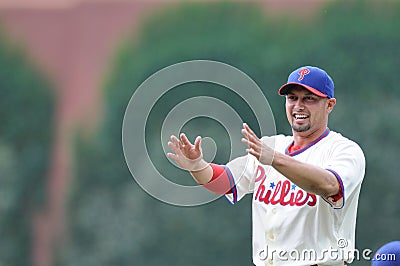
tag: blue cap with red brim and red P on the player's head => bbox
[278,66,335,98]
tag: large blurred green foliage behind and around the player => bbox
[59,1,400,265]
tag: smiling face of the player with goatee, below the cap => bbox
[286,86,336,134]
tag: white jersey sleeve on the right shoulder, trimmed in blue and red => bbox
[324,140,365,209]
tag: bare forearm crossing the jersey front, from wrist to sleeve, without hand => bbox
[272,152,339,197]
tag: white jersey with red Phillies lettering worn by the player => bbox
[226,129,365,266]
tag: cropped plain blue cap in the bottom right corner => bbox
[371,241,400,266]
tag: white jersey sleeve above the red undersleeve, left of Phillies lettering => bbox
[225,155,259,204]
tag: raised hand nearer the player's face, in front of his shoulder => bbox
[242,123,274,165]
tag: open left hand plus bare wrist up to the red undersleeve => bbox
[167,133,213,185]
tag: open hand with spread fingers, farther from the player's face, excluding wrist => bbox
[167,133,205,171]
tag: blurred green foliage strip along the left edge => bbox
[0,32,54,265]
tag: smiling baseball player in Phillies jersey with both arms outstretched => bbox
[168,66,365,266]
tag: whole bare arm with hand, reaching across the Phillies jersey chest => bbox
[242,124,339,197]
